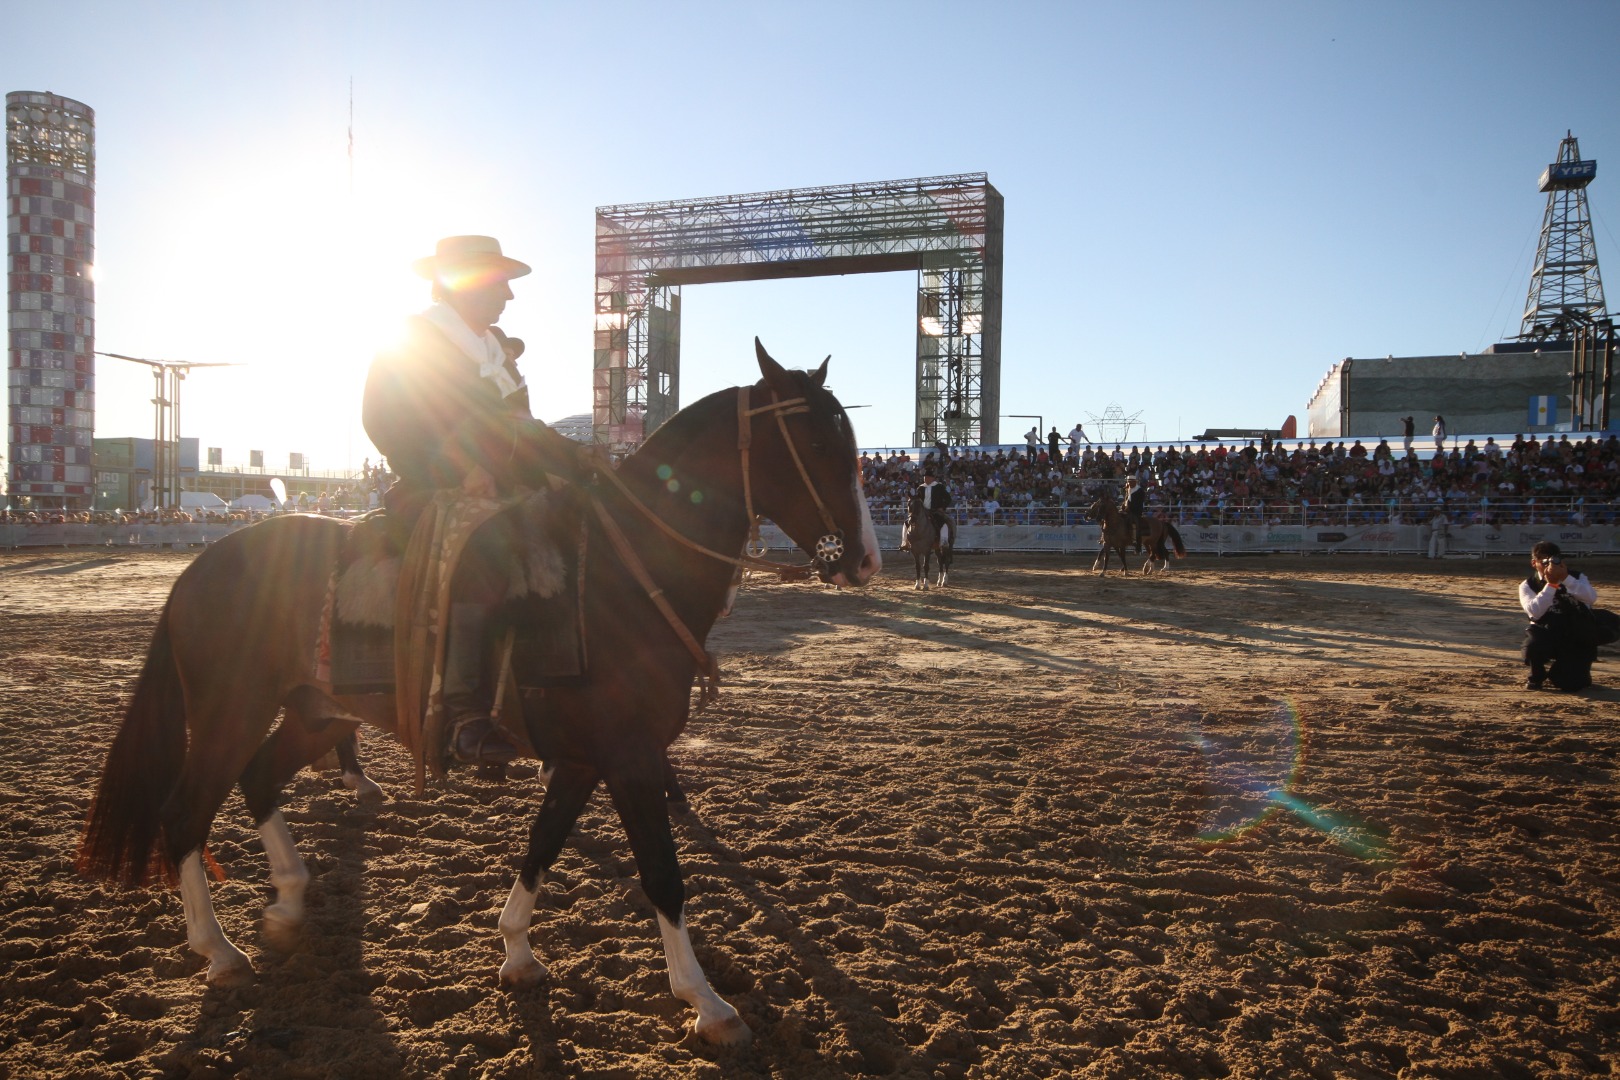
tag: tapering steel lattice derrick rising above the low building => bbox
[1520,133,1607,342]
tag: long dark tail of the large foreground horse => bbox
[78,606,186,886]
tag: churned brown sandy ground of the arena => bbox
[0,551,1620,1080]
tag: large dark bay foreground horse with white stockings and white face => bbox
[79,342,881,1043]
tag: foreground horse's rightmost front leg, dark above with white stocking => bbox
[606,753,753,1046]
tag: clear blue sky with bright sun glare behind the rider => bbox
[3,0,1620,466]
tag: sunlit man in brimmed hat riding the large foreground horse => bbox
[363,236,591,764]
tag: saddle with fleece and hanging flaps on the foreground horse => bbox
[316,486,585,789]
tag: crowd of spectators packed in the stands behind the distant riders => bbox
[860,436,1620,525]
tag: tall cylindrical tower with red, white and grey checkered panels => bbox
[5,91,96,510]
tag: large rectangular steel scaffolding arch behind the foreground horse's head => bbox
[591,173,1003,449]
